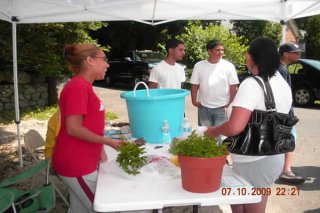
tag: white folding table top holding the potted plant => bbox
[94,145,261,212]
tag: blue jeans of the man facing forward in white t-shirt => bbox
[198,106,228,126]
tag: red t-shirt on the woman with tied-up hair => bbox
[52,76,104,177]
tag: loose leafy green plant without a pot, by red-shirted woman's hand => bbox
[117,143,147,175]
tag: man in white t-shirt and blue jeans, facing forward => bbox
[190,40,239,131]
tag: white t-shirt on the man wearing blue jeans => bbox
[190,59,239,108]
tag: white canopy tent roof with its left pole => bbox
[0,0,320,166]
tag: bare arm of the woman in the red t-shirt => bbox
[66,115,124,149]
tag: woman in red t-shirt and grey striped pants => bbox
[52,44,125,213]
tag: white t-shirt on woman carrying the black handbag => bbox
[231,71,292,162]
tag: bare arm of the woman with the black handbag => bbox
[205,107,252,137]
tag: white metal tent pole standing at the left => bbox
[12,20,23,167]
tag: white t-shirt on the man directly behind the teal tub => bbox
[149,60,186,89]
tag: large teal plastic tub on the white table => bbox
[120,85,190,144]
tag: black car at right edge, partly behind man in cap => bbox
[288,59,320,106]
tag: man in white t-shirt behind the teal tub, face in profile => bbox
[149,39,186,89]
